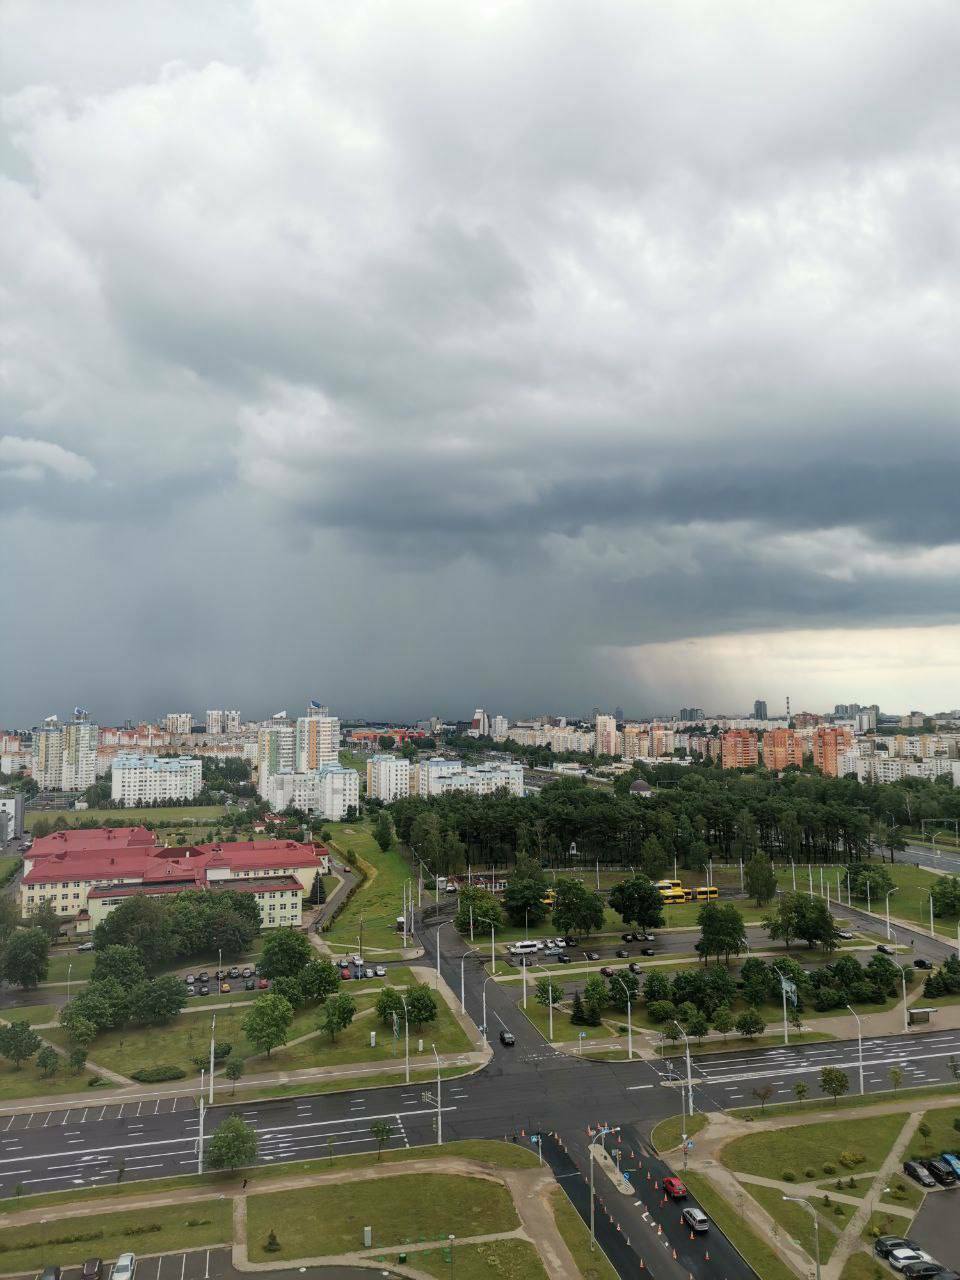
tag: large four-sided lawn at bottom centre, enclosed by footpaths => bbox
[247,1174,520,1262]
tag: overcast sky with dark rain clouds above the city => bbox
[0,0,960,724]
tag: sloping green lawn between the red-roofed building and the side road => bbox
[324,822,412,952]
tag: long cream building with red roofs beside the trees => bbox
[19,828,329,932]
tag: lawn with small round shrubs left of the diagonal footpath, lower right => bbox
[719,1112,906,1179]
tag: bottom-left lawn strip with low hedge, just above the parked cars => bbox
[0,1188,233,1274]
